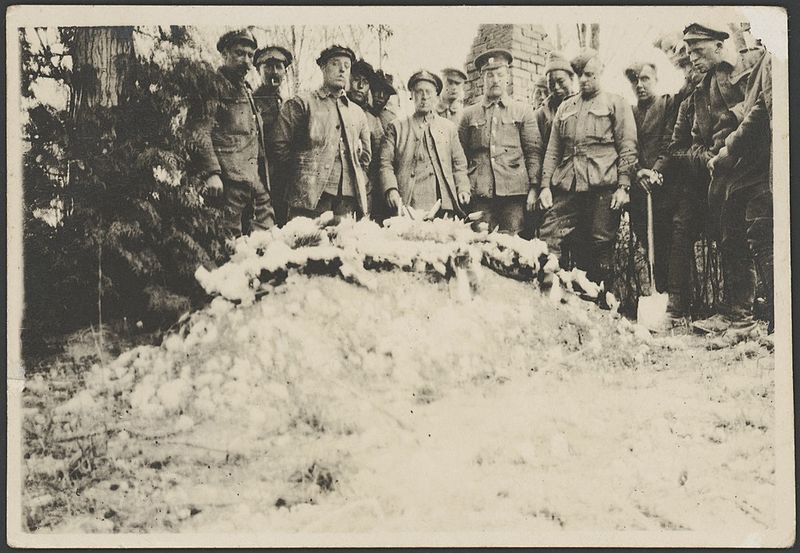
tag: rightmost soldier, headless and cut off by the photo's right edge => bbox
[709,45,775,341]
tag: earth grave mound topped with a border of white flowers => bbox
[26,212,668,530]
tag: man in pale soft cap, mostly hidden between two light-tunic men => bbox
[525,52,575,234]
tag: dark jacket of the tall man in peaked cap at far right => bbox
[692,50,762,162]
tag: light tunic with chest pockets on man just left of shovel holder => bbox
[542,91,638,192]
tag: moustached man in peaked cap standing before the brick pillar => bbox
[458,49,541,234]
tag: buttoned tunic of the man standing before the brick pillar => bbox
[458,96,541,198]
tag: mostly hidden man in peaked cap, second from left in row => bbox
[253,46,292,226]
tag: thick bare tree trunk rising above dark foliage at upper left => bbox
[71,27,133,118]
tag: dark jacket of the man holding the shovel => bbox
[632,94,677,172]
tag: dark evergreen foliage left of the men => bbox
[20,28,228,354]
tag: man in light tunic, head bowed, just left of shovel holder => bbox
[539,50,637,305]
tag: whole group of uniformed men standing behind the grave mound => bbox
[201,23,772,336]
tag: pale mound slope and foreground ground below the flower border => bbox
[23,217,775,533]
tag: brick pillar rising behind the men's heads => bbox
[464,24,553,105]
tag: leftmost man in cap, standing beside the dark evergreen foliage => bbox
[198,29,274,238]
